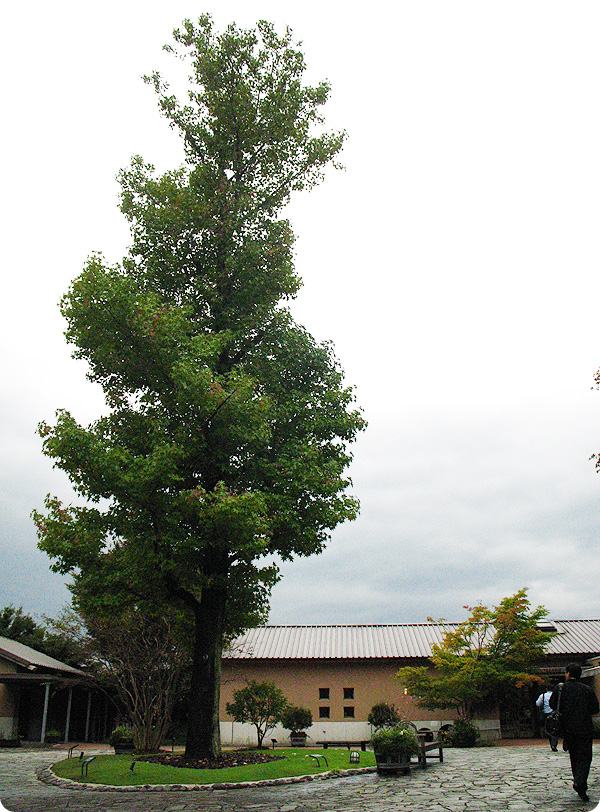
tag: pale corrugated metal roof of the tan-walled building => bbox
[224,620,600,660]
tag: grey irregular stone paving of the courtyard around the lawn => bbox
[0,744,600,812]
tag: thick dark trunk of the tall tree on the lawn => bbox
[185,586,227,759]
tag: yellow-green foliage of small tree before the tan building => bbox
[397,589,551,720]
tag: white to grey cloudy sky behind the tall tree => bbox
[0,0,600,623]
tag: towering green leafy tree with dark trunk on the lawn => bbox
[35,16,364,758]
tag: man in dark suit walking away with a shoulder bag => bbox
[550,663,600,801]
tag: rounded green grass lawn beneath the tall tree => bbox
[52,747,375,787]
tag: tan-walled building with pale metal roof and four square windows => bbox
[220,620,600,744]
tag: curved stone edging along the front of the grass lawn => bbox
[37,767,377,792]
